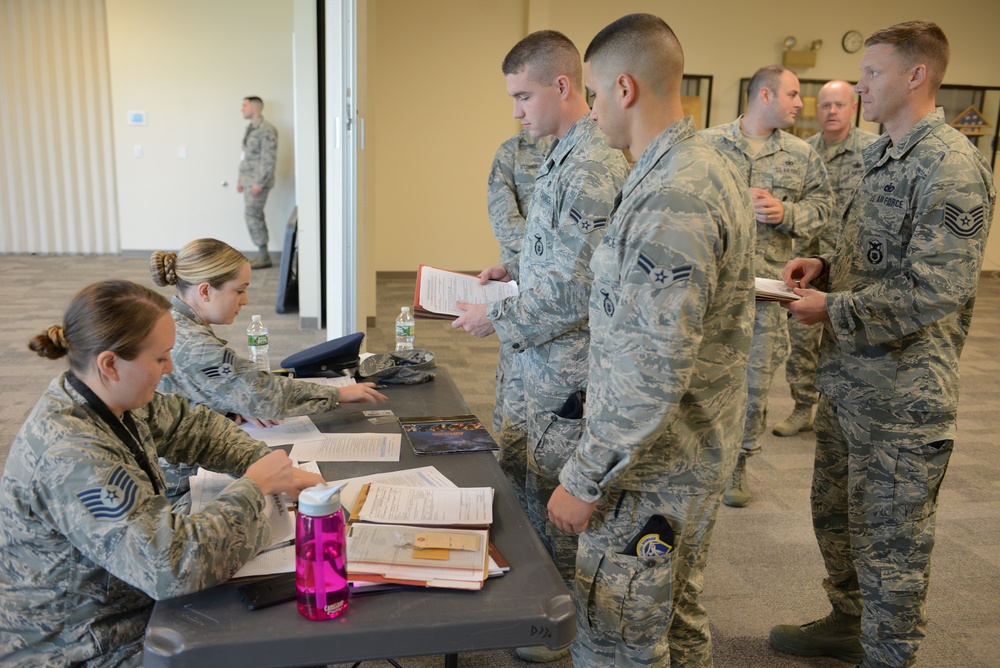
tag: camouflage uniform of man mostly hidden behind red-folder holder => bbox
[487,130,549,504]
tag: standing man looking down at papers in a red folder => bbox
[452,30,628,664]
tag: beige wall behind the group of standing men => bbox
[367,0,1000,274]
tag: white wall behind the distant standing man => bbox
[106,0,295,251]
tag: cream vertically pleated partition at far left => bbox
[0,0,119,254]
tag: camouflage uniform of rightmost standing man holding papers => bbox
[812,109,996,666]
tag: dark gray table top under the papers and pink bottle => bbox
[144,369,576,667]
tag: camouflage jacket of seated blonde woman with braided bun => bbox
[159,296,340,498]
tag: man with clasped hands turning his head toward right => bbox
[700,65,833,507]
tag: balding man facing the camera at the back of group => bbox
[772,81,878,436]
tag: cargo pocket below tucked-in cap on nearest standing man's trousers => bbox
[587,549,674,647]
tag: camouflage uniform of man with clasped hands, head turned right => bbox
[700,116,833,454]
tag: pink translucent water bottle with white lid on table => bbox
[295,483,348,619]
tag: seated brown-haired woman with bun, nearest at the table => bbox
[0,281,322,666]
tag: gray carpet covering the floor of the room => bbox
[0,256,1000,668]
